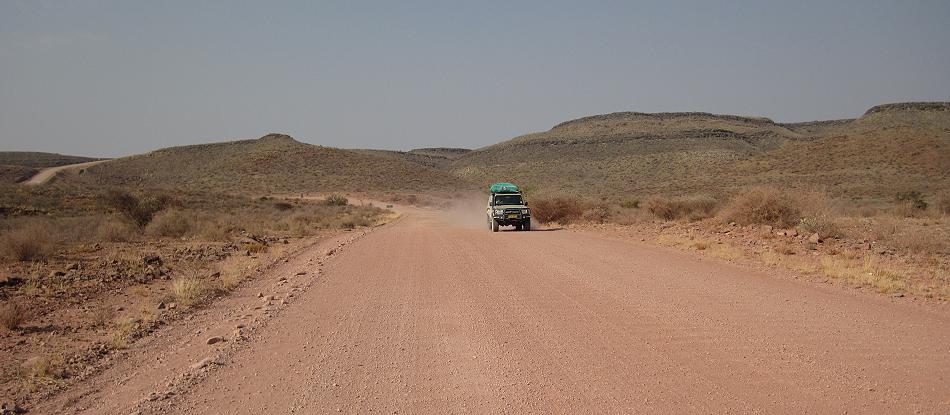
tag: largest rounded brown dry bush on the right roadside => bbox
[721,187,802,227]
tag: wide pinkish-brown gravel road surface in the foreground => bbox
[41,209,950,414]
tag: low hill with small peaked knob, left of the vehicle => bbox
[67,134,463,193]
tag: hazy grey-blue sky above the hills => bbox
[0,0,950,156]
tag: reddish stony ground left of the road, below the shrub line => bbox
[0,231,368,413]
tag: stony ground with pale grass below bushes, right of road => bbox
[584,219,950,303]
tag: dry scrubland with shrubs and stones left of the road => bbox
[0,186,388,402]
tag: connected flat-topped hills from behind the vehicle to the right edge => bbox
[449,103,950,202]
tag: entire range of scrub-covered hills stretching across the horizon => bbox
[18,103,950,200]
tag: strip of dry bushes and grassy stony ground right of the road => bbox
[548,186,950,300]
